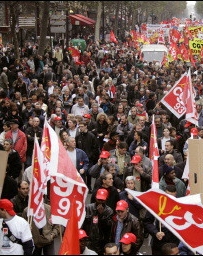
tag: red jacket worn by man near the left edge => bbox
[5,129,27,163]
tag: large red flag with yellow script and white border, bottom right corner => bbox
[125,188,203,255]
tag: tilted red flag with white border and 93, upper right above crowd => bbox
[160,72,187,119]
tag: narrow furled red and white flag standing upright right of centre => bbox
[149,115,159,188]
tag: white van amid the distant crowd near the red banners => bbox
[141,44,168,63]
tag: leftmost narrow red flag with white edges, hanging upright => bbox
[27,135,46,228]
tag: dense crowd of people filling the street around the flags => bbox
[0,39,203,255]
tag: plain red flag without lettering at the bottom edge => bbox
[58,200,80,255]
